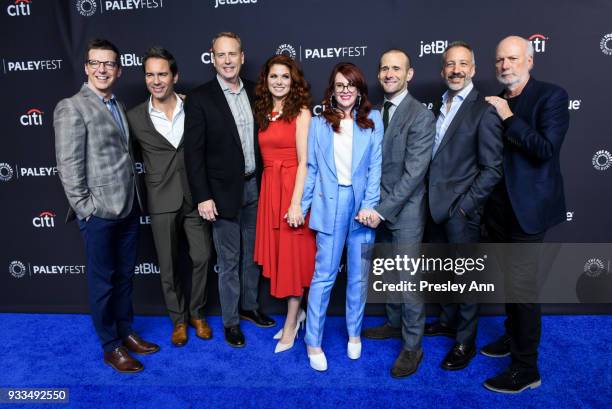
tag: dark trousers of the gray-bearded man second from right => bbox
[425,210,480,345]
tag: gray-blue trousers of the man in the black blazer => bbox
[212,178,260,328]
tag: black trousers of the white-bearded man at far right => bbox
[485,183,546,371]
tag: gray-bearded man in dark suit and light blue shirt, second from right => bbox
[425,42,503,370]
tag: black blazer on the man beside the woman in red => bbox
[183,77,262,218]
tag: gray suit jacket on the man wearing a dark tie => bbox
[375,93,436,242]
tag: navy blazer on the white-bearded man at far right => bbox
[503,78,569,234]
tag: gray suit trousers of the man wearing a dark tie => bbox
[376,223,426,351]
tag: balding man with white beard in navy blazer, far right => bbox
[481,36,569,393]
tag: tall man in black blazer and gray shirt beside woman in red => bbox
[185,32,275,347]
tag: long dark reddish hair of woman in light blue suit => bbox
[321,62,374,132]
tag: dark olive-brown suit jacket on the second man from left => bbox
[128,99,193,214]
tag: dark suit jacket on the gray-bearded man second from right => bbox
[428,88,503,223]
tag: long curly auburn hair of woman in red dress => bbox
[255,54,310,130]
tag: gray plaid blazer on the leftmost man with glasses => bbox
[53,84,138,221]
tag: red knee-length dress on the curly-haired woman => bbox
[255,115,316,298]
